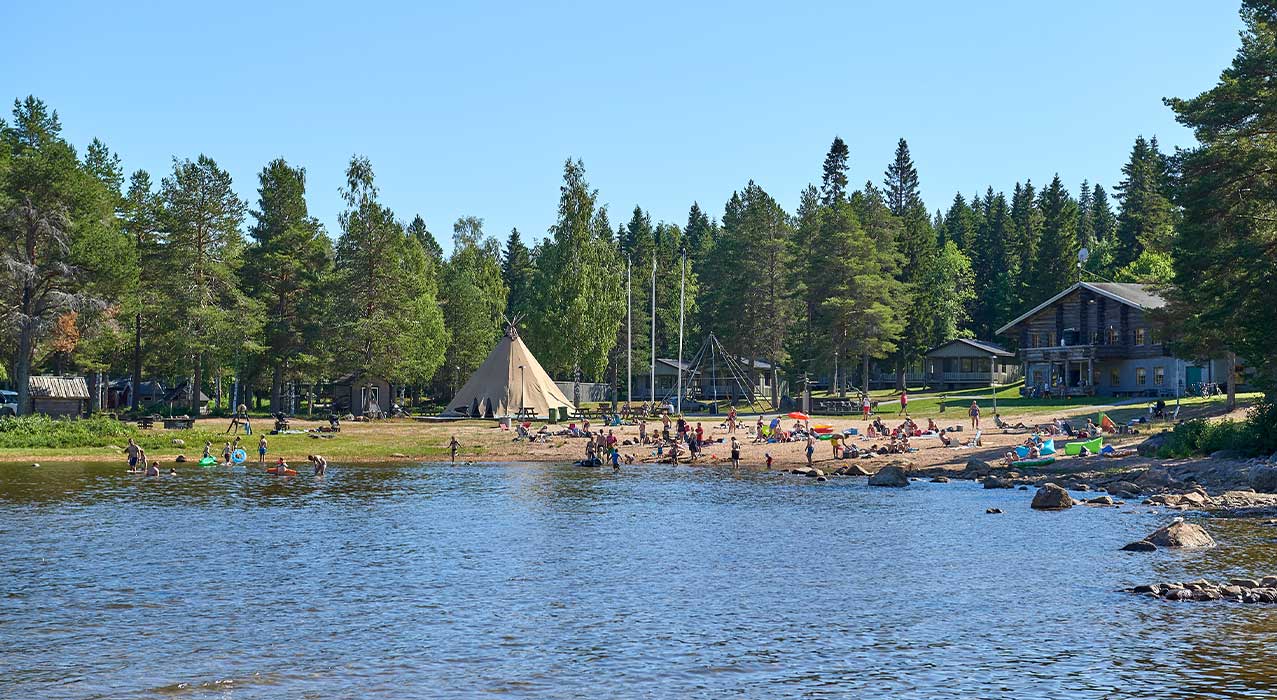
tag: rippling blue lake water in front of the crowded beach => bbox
[0,465,1277,699]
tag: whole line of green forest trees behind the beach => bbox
[0,1,1277,409]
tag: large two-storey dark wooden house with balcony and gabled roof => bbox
[997,282,1227,396]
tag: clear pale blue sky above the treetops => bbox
[0,0,1241,248]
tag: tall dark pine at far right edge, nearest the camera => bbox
[1165,0,1277,393]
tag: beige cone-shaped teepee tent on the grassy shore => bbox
[443,323,575,418]
